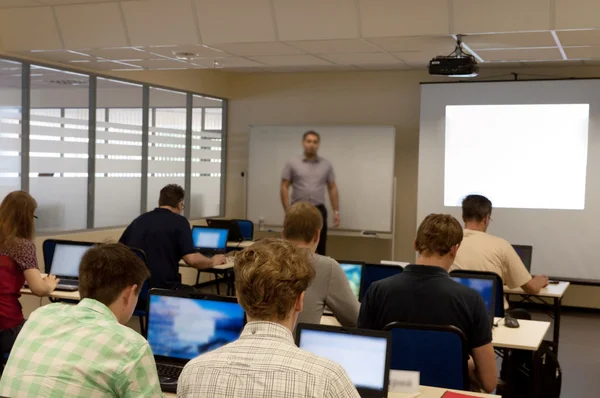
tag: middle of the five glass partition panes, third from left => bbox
[94,78,143,227]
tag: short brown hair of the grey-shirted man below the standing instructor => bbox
[283,202,323,243]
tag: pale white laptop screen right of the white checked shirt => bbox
[299,329,388,391]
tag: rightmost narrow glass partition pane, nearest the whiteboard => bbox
[189,95,223,219]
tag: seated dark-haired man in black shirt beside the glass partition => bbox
[119,184,225,289]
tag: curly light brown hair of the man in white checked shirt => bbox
[234,238,315,321]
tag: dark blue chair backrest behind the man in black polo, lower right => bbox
[384,322,470,390]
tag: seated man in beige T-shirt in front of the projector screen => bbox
[452,195,548,294]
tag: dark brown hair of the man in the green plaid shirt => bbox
[79,243,150,306]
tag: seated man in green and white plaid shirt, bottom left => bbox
[0,244,162,398]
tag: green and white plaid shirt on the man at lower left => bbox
[0,299,163,398]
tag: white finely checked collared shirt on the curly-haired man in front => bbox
[177,322,359,398]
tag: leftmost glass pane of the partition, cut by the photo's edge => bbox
[0,60,22,201]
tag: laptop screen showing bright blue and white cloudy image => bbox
[148,294,245,359]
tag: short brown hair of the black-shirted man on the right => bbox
[415,214,463,256]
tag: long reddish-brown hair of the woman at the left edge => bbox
[0,191,37,247]
